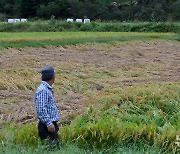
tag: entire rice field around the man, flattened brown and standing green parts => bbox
[0,32,180,153]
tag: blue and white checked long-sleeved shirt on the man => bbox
[35,81,60,127]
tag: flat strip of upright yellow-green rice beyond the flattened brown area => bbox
[0,31,179,48]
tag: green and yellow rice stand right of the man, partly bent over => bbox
[60,84,180,150]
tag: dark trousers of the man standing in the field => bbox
[38,122,59,143]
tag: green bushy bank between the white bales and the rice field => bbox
[0,21,180,32]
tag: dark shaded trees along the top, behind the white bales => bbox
[0,0,180,21]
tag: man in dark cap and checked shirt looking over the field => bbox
[35,66,60,143]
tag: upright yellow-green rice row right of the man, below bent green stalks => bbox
[60,112,176,149]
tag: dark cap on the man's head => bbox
[41,66,56,81]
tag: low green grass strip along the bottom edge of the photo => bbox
[0,142,160,154]
